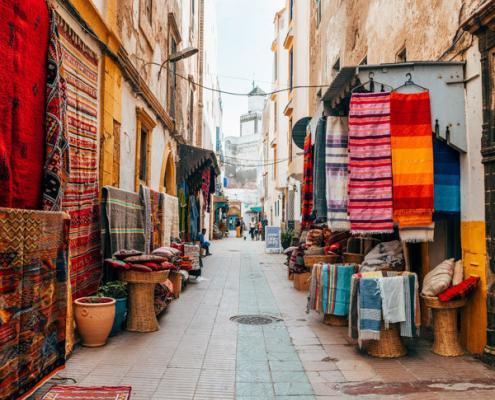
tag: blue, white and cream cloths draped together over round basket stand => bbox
[349,271,421,344]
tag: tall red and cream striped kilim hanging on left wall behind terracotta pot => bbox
[57,15,102,299]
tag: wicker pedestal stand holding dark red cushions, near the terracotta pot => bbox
[120,271,169,332]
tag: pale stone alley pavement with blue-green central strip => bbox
[33,238,495,400]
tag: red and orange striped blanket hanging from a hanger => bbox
[390,92,433,228]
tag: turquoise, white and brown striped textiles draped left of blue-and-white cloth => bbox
[309,264,357,316]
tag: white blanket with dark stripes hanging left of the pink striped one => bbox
[325,117,350,231]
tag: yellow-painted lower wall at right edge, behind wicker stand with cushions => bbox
[461,221,487,353]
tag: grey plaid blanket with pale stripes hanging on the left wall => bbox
[101,186,145,258]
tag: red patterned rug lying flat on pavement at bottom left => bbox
[42,386,131,400]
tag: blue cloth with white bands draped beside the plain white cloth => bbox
[359,278,382,340]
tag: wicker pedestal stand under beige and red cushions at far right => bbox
[421,296,466,357]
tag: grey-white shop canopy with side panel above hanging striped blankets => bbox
[318,61,472,152]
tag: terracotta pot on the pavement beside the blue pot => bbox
[74,297,115,347]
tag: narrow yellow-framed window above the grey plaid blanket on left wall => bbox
[135,108,156,191]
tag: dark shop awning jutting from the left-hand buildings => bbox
[177,144,220,181]
